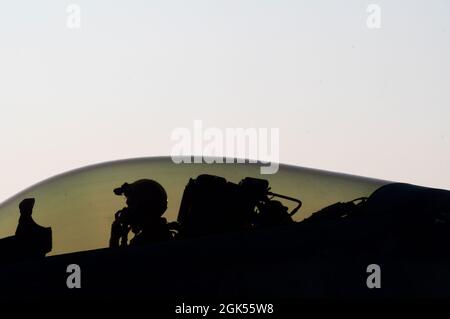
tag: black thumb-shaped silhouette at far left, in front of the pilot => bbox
[0,198,52,261]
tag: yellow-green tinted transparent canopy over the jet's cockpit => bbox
[0,157,388,255]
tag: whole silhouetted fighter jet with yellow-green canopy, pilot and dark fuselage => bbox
[0,157,450,300]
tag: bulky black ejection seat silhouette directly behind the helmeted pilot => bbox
[178,175,301,237]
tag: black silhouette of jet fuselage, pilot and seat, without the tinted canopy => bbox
[0,175,450,300]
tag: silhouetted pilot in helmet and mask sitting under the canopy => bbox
[109,179,173,247]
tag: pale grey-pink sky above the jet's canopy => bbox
[0,0,450,201]
